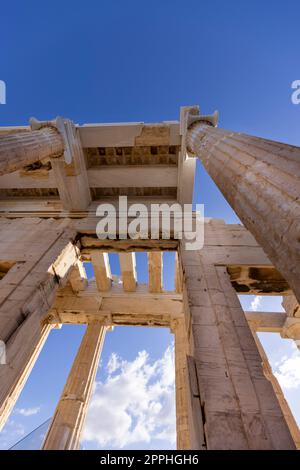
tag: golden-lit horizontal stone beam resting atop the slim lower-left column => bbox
[45,282,183,326]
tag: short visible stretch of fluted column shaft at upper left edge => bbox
[0,127,64,175]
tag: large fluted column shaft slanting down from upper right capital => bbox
[186,121,300,302]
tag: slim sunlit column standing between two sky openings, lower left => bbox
[43,322,106,450]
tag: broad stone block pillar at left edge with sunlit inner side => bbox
[0,218,79,429]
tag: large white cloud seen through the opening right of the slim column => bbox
[83,347,176,448]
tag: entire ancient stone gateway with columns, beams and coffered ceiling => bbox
[0,107,300,450]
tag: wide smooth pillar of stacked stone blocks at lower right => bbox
[180,248,295,450]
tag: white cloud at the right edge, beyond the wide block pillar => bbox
[274,349,300,389]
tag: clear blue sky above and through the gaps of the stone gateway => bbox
[0,0,300,447]
